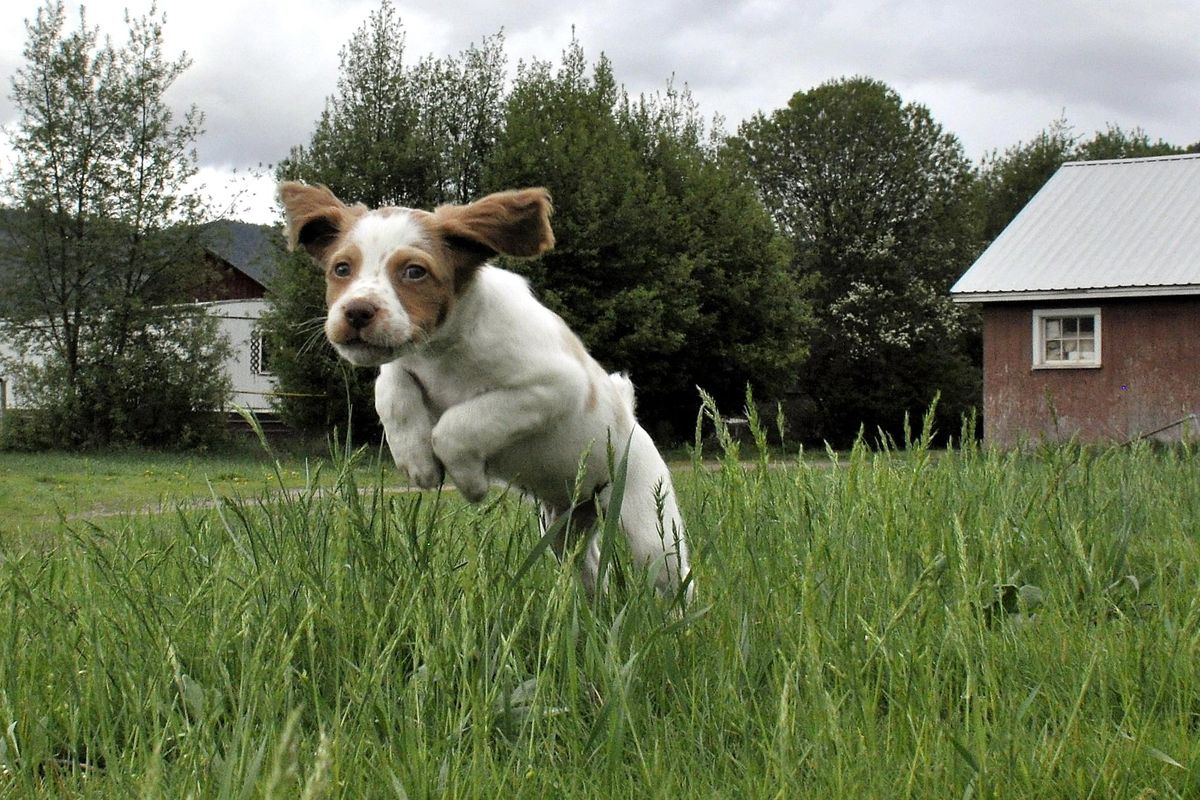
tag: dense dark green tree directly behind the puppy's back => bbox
[487,41,804,437]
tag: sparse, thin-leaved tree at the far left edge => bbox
[4,1,228,444]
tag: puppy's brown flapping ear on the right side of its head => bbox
[433,188,554,273]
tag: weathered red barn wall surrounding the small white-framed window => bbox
[983,297,1200,446]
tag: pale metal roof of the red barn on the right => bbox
[950,155,1200,302]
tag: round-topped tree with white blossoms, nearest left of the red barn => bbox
[733,78,979,444]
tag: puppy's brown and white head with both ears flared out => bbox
[280,181,554,366]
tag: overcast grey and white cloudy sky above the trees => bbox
[0,0,1200,222]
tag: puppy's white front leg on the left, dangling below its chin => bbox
[376,362,443,489]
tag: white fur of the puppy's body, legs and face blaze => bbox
[360,260,692,597]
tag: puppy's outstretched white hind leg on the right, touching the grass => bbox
[601,426,695,602]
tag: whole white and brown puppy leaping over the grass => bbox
[280,182,692,599]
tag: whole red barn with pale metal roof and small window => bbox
[950,155,1200,446]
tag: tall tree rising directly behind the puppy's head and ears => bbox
[270,0,505,438]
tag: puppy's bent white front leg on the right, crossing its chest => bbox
[433,384,569,503]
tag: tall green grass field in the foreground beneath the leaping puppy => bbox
[0,410,1200,798]
